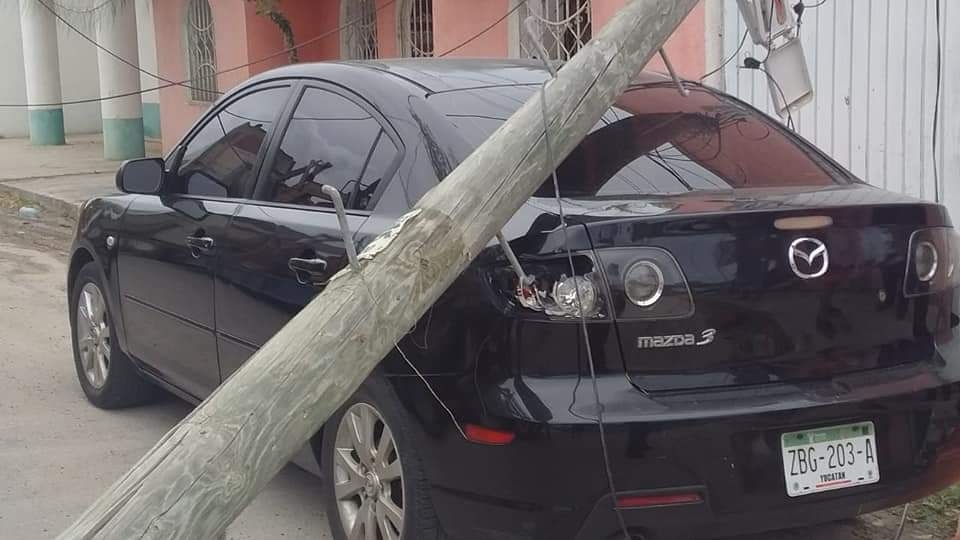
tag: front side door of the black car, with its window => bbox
[118,84,290,398]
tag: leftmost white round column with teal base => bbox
[20,0,66,145]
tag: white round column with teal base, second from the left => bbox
[97,2,144,160]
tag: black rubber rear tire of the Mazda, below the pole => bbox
[321,375,446,540]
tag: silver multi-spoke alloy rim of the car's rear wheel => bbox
[333,403,404,540]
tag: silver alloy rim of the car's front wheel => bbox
[76,283,110,389]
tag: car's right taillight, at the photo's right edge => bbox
[903,227,960,298]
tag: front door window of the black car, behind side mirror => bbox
[170,87,290,197]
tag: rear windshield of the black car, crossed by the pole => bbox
[430,84,851,198]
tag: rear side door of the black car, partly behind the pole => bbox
[216,82,402,379]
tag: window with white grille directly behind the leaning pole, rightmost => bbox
[515,0,593,61]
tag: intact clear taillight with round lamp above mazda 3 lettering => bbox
[597,247,694,320]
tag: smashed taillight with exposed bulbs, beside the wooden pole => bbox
[492,252,608,320]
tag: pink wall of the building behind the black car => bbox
[153,0,705,150]
